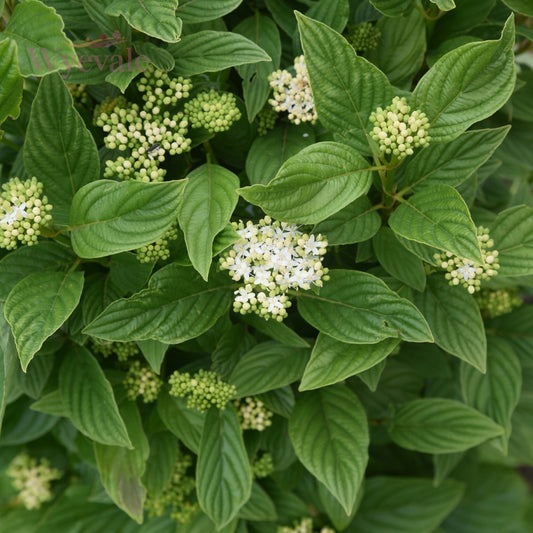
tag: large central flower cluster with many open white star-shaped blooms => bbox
[220,216,328,322]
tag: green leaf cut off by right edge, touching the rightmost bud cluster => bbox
[490,205,533,276]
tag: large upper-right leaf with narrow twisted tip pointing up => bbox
[410,16,516,143]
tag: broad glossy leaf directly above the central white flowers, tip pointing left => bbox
[238,142,372,224]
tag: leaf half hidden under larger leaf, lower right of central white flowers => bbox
[299,333,399,391]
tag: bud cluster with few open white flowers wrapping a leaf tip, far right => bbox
[435,226,500,294]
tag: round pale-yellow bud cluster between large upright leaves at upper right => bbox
[370,96,431,160]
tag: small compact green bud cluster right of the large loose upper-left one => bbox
[185,89,241,133]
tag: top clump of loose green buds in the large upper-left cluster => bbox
[137,65,192,109]
